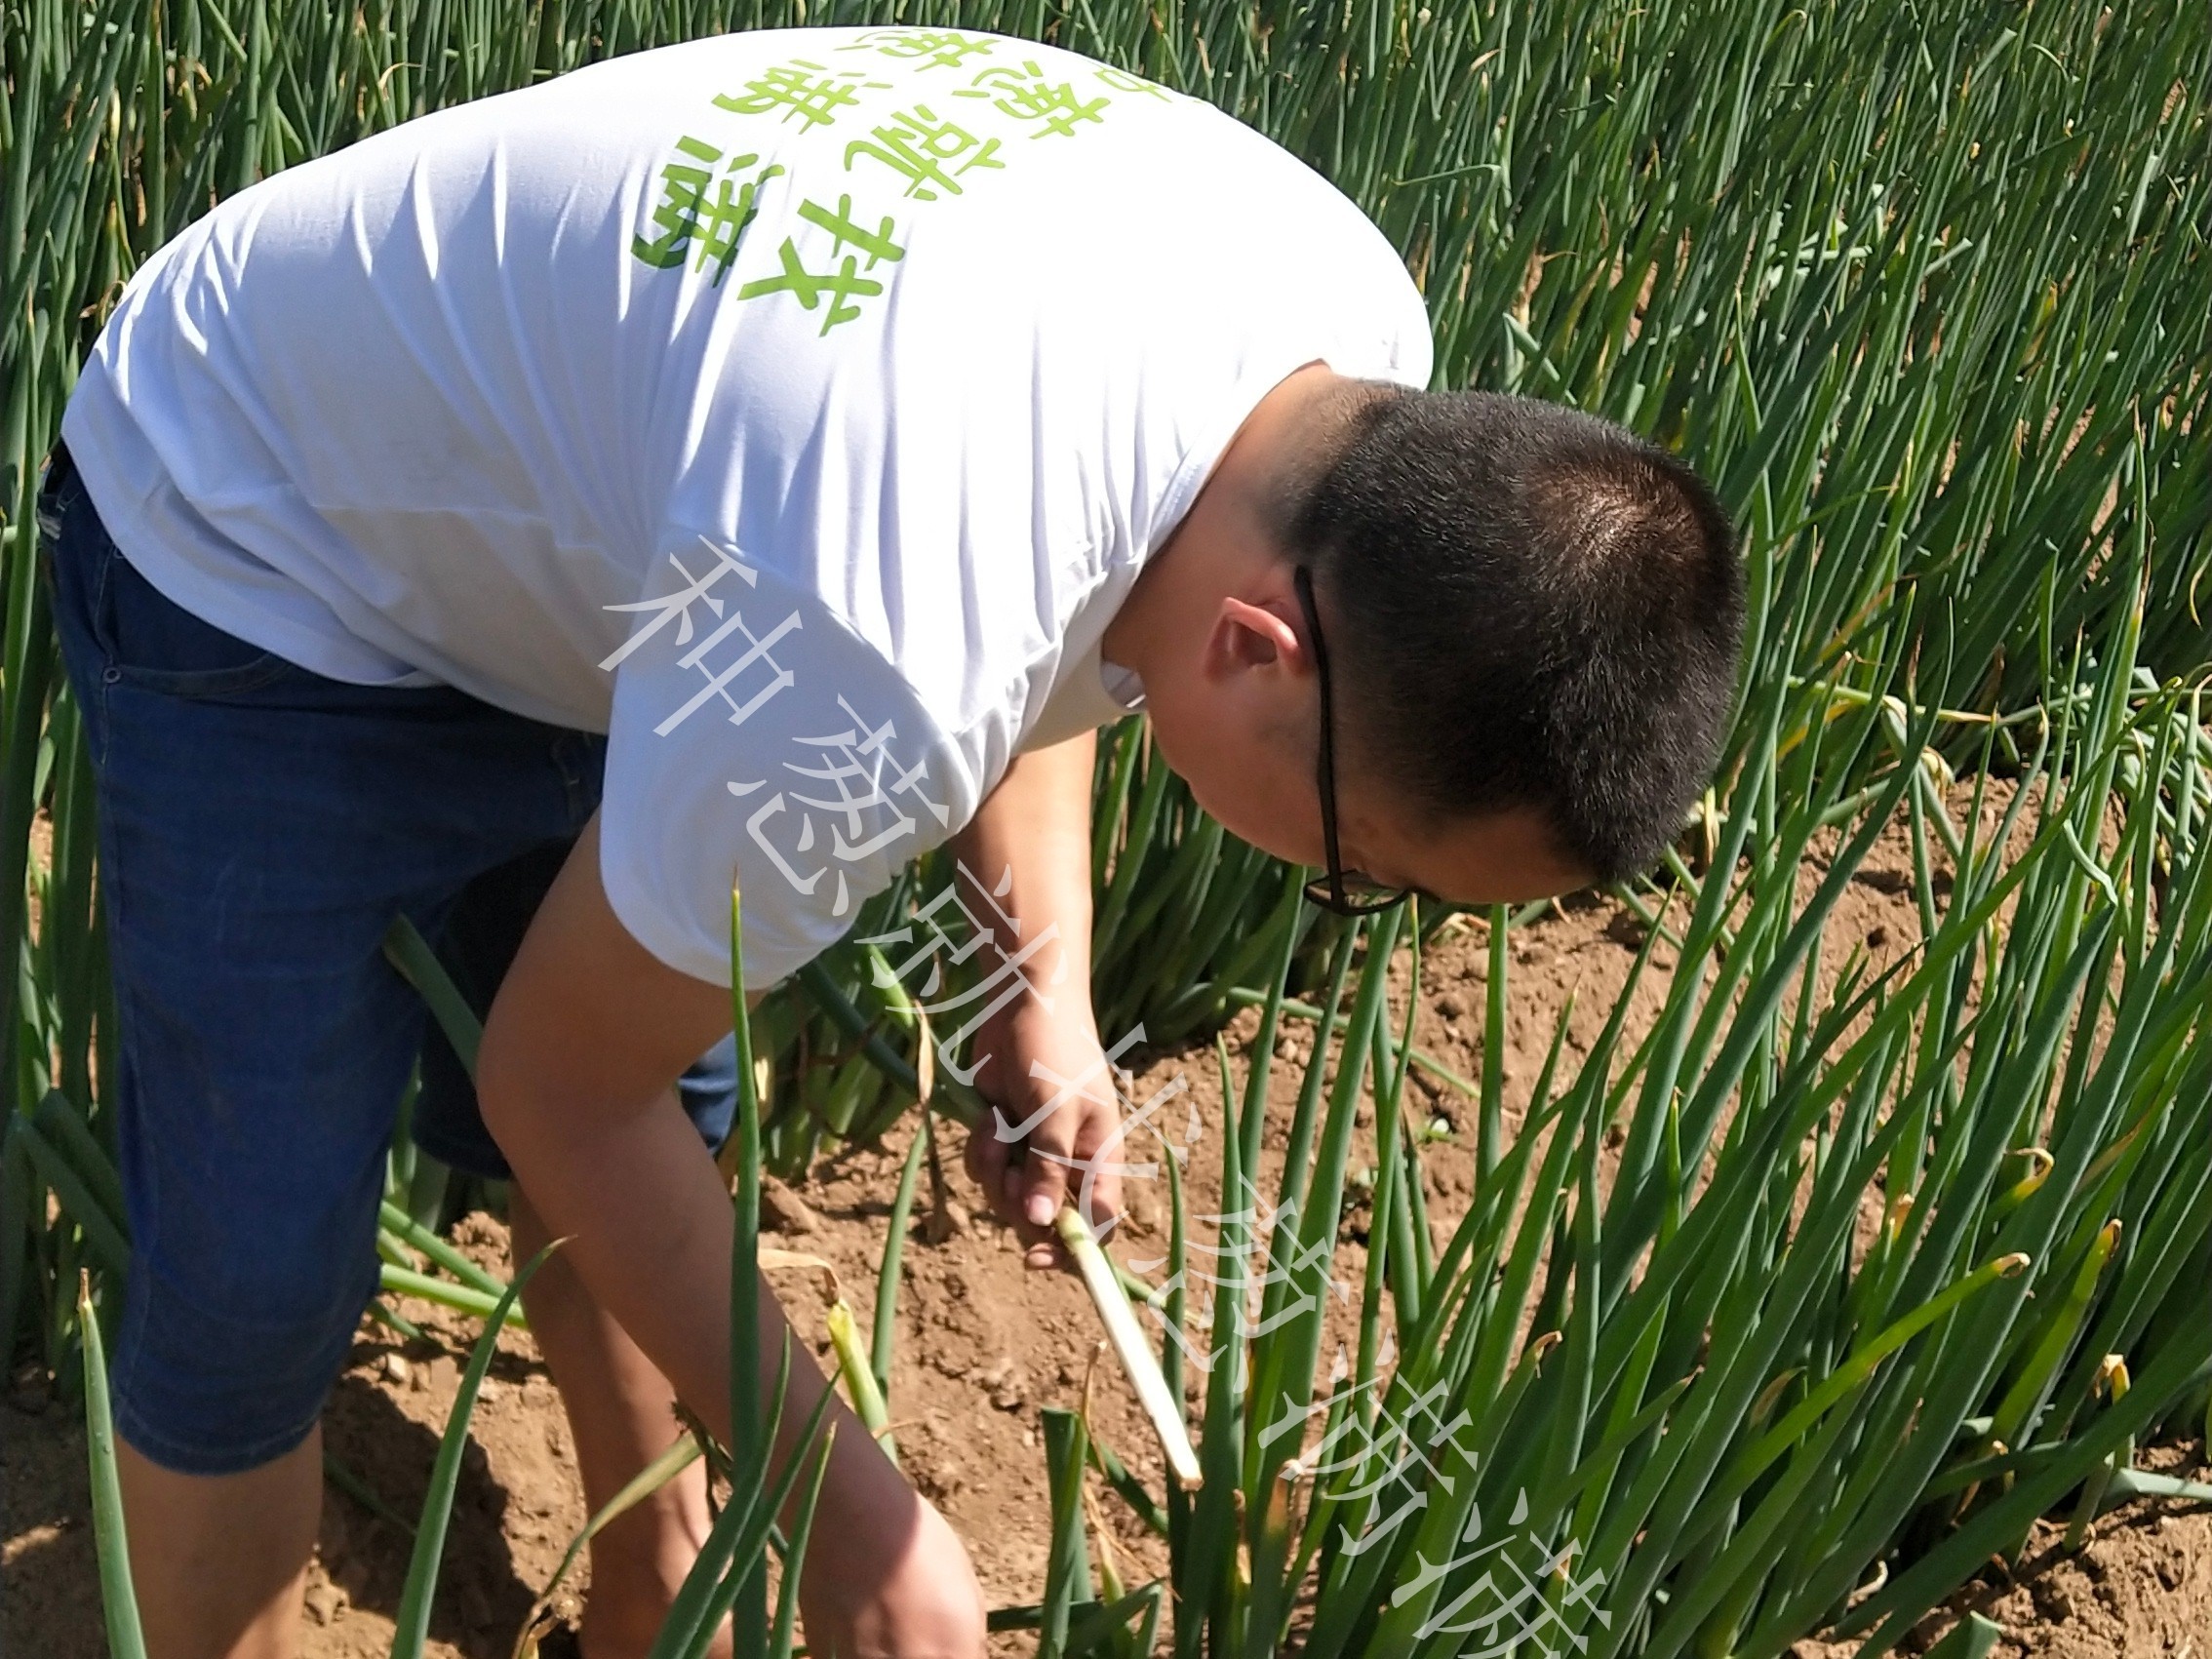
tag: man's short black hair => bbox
[1283,387,1743,881]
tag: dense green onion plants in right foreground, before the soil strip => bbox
[1035,588,2212,1659]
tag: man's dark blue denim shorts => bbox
[38,454,734,1473]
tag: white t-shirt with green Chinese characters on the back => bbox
[62,28,1431,987]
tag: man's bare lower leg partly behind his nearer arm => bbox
[509,1186,730,1659]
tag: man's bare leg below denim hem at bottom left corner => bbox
[115,1427,323,1659]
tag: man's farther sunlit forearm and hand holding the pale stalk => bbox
[954,732,1122,1265]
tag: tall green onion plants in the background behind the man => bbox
[0,0,2212,1309]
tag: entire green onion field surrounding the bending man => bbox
[0,0,2212,1659]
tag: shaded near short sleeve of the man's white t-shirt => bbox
[600,539,977,991]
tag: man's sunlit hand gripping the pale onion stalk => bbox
[967,998,1122,1268]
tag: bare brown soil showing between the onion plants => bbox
[0,787,2212,1659]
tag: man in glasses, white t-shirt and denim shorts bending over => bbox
[42,28,1741,1659]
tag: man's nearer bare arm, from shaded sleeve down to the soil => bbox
[478,818,982,1659]
